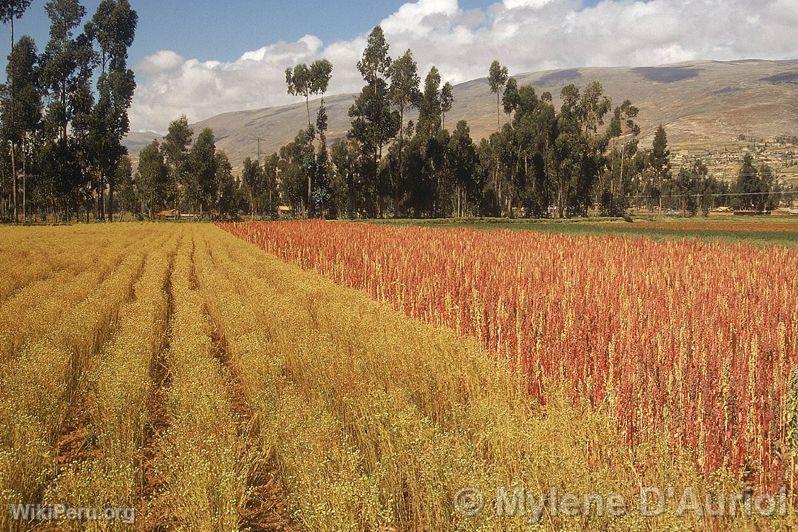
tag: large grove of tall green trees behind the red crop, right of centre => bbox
[250,26,788,217]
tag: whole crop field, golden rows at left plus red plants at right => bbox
[0,222,798,531]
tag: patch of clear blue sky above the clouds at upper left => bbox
[0,0,500,64]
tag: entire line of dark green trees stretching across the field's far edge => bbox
[0,10,780,221]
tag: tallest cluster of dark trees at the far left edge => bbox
[0,0,138,221]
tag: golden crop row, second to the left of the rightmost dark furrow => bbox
[45,233,179,529]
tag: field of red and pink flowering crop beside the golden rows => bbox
[223,221,798,490]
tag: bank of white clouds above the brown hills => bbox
[130,0,798,131]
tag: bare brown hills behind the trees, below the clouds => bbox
[126,59,798,166]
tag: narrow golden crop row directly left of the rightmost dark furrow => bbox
[143,228,251,530]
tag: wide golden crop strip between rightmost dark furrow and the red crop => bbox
[203,224,772,530]
